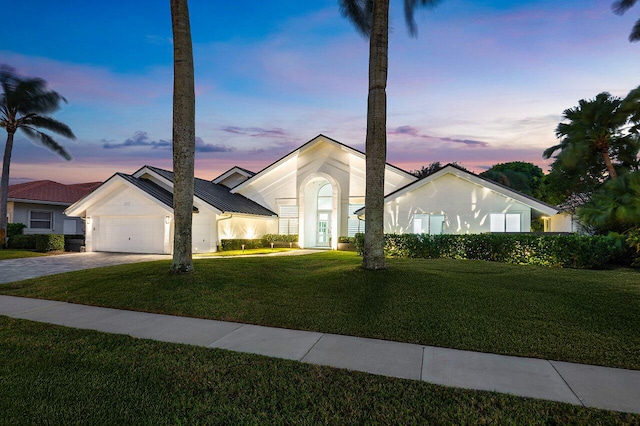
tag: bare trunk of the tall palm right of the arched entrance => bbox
[362,0,389,269]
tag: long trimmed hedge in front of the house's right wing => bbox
[356,234,616,269]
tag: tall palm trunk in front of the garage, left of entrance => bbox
[171,0,196,273]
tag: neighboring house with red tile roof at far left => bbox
[7,180,102,235]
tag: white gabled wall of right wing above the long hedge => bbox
[384,174,531,234]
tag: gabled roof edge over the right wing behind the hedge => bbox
[355,163,560,216]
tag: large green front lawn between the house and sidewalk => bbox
[0,252,640,369]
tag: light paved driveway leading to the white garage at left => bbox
[0,252,171,284]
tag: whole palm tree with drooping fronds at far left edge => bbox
[0,65,75,247]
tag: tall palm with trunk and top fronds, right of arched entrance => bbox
[340,0,437,269]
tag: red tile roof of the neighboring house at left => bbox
[9,180,102,204]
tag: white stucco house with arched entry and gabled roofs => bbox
[65,135,558,253]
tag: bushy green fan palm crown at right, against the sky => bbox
[543,92,637,179]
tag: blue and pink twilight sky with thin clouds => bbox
[0,0,640,183]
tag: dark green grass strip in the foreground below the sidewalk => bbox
[0,317,640,425]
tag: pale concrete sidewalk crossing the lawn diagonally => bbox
[0,296,640,414]
